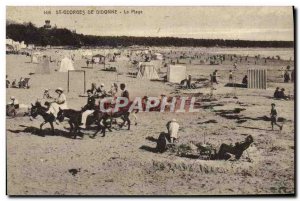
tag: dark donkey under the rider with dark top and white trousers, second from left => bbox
[57,108,106,139]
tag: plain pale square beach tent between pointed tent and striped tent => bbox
[167,65,186,83]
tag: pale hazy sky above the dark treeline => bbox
[6,6,294,41]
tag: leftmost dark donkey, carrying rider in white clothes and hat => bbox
[30,102,55,135]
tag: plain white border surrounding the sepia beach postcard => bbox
[0,0,300,200]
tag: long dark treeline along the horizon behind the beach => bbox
[6,23,294,48]
